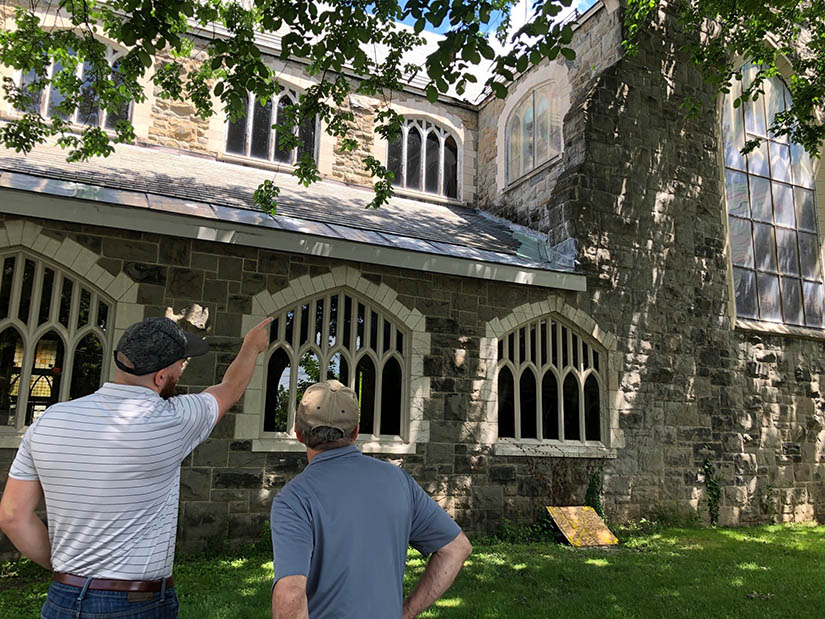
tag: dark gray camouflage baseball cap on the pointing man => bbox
[115,318,209,376]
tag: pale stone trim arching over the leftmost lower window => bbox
[0,220,144,449]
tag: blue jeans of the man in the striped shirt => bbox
[41,582,178,619]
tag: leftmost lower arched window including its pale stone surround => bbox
[0,220,142,438]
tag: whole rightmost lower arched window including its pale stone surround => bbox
[480,296,623,457]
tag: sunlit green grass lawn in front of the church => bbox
[0,525,825,619]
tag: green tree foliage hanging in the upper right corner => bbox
[624,0,825,157]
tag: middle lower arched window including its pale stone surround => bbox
[240,267,430,453]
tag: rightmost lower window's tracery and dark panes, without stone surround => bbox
[497,315,606,445]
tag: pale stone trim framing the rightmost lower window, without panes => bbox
[479,296,624,458]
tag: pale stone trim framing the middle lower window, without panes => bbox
[234,266,431,454]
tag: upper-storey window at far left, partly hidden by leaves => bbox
[20,48,131,129]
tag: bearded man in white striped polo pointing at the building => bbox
[0,318,271,619]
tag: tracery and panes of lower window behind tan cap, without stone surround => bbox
[264,289,409,438]
